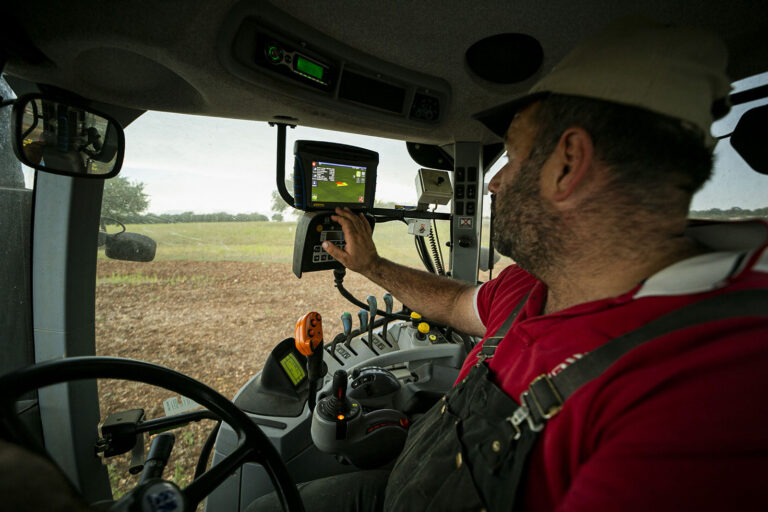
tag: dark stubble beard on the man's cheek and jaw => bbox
[493,156,563,280]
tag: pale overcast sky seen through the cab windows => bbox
[121,74,768,214]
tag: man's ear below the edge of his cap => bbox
[542,126,594,202]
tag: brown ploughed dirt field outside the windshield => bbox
[96,260,504,496]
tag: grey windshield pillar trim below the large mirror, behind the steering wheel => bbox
[32,172,111,502]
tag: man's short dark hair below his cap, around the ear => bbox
[532,94,712,208]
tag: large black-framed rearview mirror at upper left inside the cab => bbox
[12,94,125,179]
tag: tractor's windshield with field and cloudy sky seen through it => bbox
[96,117,460,494]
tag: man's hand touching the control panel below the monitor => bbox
[323,208,379,275]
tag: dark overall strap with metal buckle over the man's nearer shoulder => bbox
[509,289,768,431]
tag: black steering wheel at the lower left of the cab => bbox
[0,357,304,512]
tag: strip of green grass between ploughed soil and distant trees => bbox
[99,221,476,268]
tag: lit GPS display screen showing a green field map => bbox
[312,161,367,204]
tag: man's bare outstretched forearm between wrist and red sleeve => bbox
[363,258,483,335]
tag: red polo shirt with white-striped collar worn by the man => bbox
[459,221,768,512]
